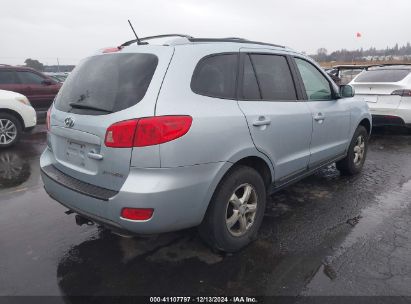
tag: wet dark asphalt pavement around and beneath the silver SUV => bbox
[0,125,411,301]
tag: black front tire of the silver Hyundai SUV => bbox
[336,126,369,175]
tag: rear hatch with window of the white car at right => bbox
[351,68,410,110]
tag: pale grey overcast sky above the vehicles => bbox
[0,0,411,64]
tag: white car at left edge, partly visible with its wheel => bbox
[0,90,37,149]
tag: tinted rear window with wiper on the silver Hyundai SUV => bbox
[55,53,158,115]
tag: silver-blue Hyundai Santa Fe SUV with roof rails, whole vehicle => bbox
[40,35,371,252]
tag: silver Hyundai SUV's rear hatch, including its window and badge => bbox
[48,45,174,191]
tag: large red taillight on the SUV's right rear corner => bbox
[105,116,193,148]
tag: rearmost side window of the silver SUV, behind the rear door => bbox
[191,54,238,99]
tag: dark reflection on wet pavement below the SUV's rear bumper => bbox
[57,231,284,295]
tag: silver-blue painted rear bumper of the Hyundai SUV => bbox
[40,149,231,234]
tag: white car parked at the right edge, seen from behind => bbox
[350,65,411,129]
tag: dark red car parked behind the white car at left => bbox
[0,65,61,112]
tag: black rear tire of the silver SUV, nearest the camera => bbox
[199,166,266,252]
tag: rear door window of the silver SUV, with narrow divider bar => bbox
[243,54,297,101]
